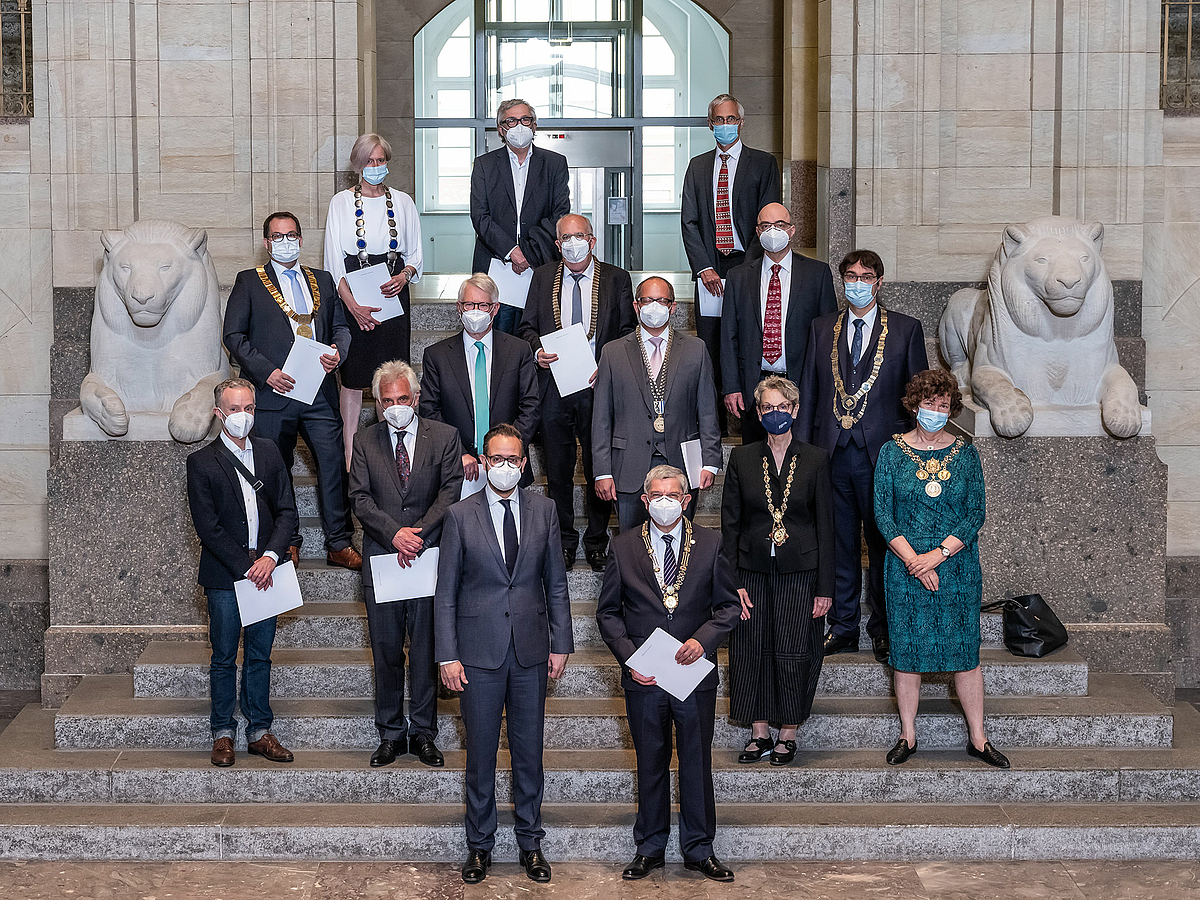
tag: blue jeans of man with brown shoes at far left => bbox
[205,588,275,742]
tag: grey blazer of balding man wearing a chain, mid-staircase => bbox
[592,328,721,493]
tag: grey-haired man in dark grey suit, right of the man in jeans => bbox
[350,360,462,767]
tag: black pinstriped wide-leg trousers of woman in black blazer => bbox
[730,563,824,727]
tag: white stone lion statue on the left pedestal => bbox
[79,218,229,444]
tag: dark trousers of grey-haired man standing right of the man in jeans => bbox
[362,588,438,742]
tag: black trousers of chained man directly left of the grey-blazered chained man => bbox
[541,379,612,556]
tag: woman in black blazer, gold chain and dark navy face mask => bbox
[721,376,834,766]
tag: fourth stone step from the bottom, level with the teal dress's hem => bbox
[133,641,1087,698]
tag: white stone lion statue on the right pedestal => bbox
[938,216,1141,438]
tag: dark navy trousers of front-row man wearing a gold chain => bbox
[625,688,716,863]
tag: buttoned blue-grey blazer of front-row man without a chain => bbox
[433,490,575,668]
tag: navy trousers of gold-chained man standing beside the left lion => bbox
[251,398,354,552]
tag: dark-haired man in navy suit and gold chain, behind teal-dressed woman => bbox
[796,250,929,662]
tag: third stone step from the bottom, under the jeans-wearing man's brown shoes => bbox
[54,676,1172,750]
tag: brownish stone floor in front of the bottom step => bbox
[0,862,1200,900]
